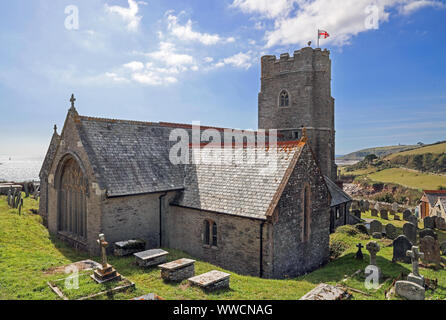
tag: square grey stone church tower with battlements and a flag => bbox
[259,47,337,181]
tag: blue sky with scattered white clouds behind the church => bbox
[0,0,446,156]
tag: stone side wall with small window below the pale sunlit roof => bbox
[165,206,270,276]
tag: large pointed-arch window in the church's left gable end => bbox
[58,157,88,240]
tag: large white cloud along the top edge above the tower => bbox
[231,0,445,48]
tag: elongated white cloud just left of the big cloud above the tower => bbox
[167,14,235,45]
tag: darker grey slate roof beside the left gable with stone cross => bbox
[78,116,184,197]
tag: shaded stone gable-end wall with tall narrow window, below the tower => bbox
[272,145,330,278]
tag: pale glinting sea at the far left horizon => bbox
[0,155,44,182]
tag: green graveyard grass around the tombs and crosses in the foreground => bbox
[0,197,446,300]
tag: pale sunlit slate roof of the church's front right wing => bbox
[172,141,305,219]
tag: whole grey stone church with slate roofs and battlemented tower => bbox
[39,47,351,278]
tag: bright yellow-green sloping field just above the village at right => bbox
[367,168,446,190]
